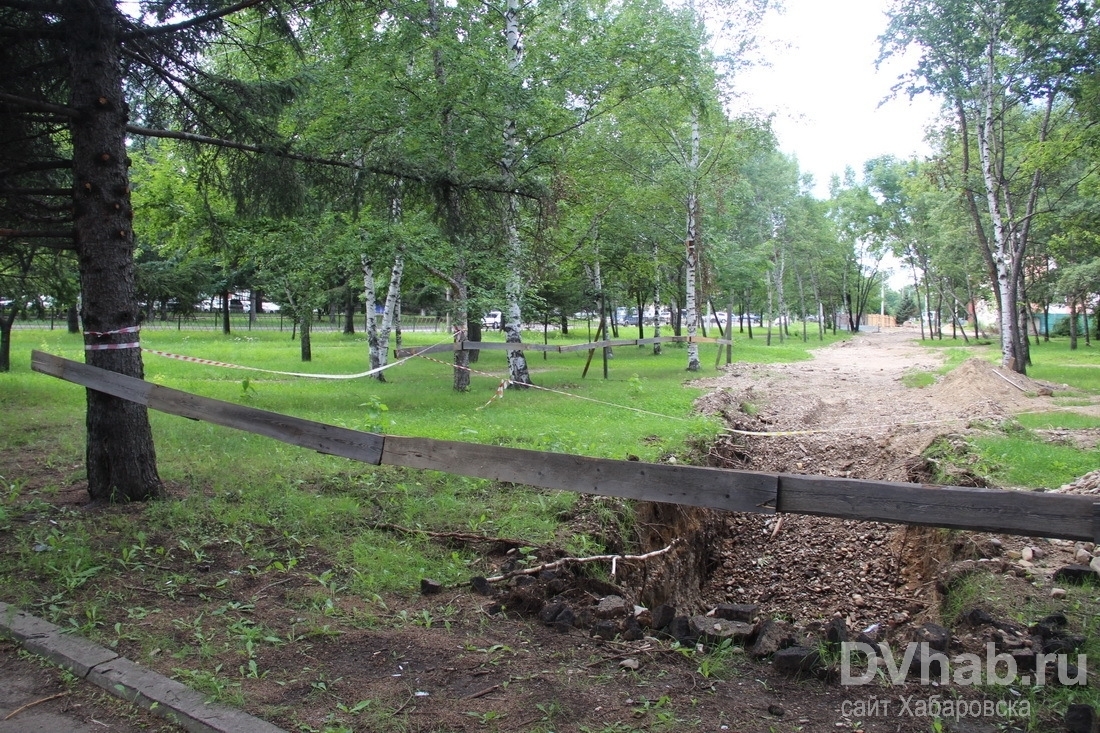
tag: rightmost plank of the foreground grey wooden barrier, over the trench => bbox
[778,471,1093,540]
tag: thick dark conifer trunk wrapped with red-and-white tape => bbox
[64,0,162,502]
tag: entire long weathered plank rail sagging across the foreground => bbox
[31,351,1100,543]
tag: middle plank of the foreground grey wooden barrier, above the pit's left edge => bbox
[382,436,777,514]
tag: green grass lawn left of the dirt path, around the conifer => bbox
[0,329,844,597]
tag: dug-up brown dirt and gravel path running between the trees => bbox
[700,329,1086,630]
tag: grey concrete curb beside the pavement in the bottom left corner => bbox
[0,602,286,733]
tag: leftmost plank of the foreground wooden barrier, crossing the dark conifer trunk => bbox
[31,351,383,466]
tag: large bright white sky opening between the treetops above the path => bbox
[734,0,938,198]
